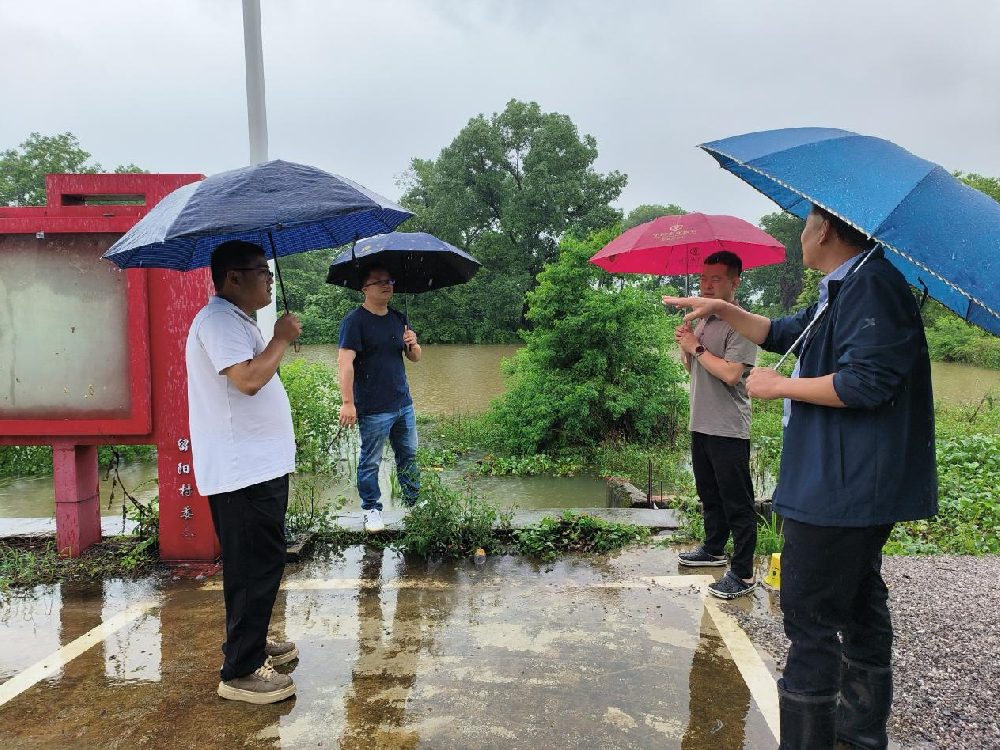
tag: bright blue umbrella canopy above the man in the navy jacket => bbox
[701,128,1000,335]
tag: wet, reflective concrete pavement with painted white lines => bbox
[0,547,777,748]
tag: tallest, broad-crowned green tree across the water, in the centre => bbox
[401,99,627,341]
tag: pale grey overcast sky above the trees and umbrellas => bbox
[0,0,1000,222]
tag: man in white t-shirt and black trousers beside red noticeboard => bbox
[186,240,302,704]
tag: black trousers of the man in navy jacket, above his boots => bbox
[779,518,892,696]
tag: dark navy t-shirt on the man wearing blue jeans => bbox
[339,307,413,417]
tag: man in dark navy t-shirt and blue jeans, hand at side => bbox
[337,265,421,534]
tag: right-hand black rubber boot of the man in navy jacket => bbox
[837,657,892,750]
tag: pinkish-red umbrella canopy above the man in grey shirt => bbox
[590,213,785,276]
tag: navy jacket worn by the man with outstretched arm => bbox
[762,250,937,526]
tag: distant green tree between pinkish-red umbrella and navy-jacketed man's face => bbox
[737,212,805,315]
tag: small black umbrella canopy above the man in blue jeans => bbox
[326,232,482,294]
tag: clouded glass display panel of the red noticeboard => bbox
[0,234,131,419]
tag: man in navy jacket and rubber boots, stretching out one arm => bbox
[663,206,937,748]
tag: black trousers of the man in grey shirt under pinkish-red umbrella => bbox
[691,432,757,578]
